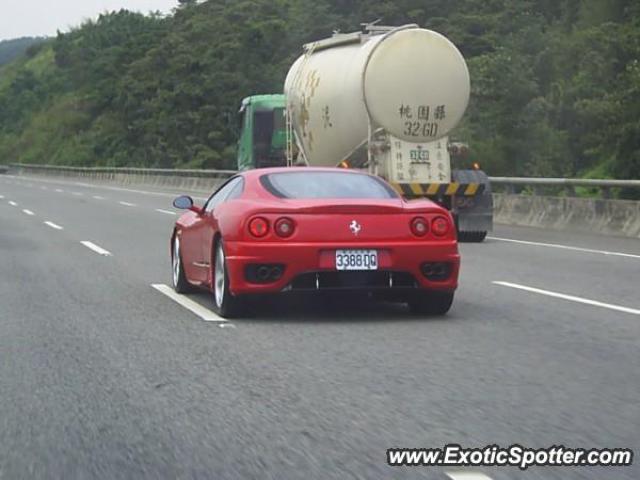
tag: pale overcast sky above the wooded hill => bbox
[0,0,178,40]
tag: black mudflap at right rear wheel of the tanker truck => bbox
[451,170,493,242]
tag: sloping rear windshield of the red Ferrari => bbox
[260,171,398,199]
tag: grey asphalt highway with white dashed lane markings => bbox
[0,176,640,480]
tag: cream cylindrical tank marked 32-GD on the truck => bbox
[285,26,470,166]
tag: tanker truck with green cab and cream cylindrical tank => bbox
[237,24,493,242]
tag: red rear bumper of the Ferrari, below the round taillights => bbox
[225,240,460,295]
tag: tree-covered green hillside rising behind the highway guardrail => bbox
[0,0,640,178]
